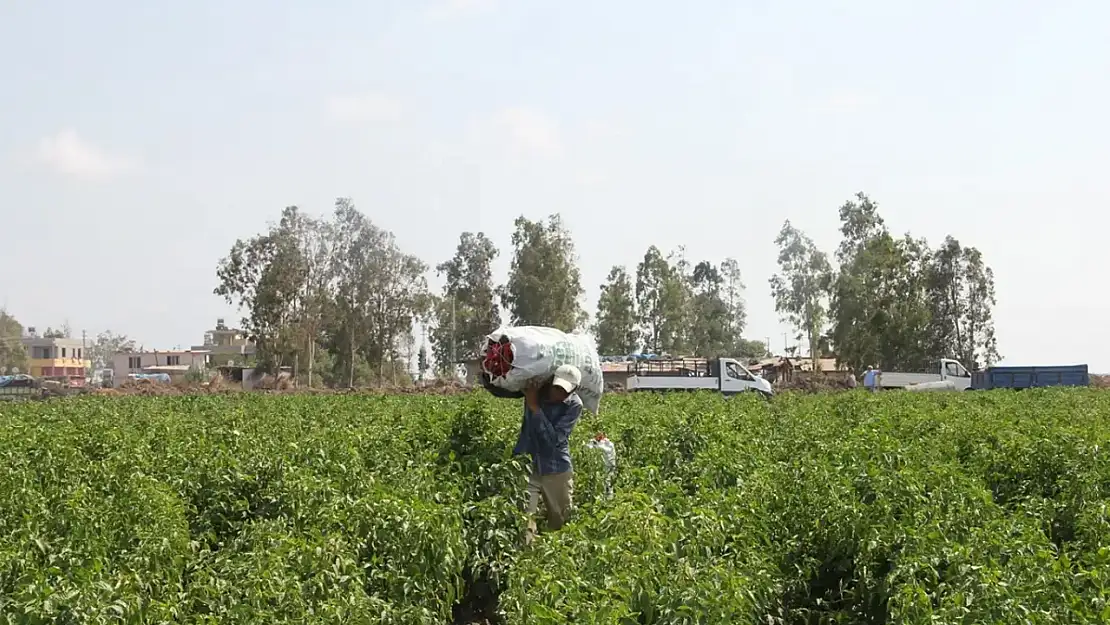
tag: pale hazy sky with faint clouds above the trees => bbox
[0,0,1110,372]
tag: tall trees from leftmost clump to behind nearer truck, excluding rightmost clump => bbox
[209,198,766,385]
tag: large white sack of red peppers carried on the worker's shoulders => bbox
[481,325,605,414]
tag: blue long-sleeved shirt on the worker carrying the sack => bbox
[513,393,582,475]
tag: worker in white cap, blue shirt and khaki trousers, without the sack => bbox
[513,365,582,543]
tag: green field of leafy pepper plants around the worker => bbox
[0,390,1110,625]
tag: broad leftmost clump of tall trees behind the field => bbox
[214,202,431,386]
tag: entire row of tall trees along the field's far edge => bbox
[208,193,998,385]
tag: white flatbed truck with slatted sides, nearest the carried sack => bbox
[625,359,775,397]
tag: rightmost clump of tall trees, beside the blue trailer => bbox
[770,193,1000,371]
